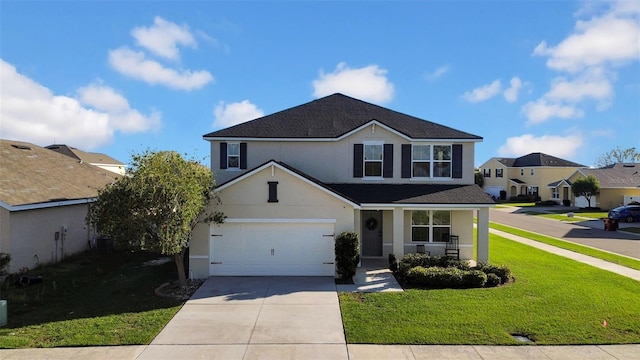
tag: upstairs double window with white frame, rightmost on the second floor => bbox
[411,145,452,178]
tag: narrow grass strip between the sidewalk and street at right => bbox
[490,222,640,270]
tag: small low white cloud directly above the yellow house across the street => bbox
[498,134,584,158]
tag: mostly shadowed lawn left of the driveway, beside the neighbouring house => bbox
[0,253,183,348]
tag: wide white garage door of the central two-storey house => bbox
[209,222,335,276]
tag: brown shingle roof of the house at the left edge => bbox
[0,140,120,206]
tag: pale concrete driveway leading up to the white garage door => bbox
[138,277,347,359]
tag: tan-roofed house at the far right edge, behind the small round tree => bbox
[564,163,640,210]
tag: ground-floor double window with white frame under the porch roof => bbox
[411,210,451,242]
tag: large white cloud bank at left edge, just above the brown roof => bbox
[0,60,161,150]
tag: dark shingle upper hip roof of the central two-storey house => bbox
[204,94,482,140]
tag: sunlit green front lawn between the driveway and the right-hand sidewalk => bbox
[339,234,640,345]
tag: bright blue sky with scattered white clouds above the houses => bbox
[0,0,640,165]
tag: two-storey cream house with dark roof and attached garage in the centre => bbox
[189,94,494,278]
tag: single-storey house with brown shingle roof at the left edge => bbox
[0,140,120,272]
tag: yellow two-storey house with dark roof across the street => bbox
[480,152,586,203]
